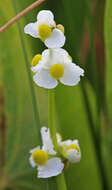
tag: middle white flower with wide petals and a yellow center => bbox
[33,48,84,89]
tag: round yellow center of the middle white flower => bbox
[50,64,64,79]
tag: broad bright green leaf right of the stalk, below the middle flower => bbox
[56,85,101,190]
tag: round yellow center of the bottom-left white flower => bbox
[32,150,48,165]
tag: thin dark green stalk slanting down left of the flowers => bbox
[12,0,41,143]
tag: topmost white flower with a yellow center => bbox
[24,10,65,48]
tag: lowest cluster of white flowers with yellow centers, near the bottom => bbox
[29,127,81,178]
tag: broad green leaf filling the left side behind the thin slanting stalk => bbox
[0,0,47,190]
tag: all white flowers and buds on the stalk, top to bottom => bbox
[24,10,84,178]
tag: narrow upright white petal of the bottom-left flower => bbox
[41,127,56,155]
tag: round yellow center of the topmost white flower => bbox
[38,24,52,40]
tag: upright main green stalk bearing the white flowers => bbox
[48,89,67,190]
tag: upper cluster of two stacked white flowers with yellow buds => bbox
[24,10,84,89]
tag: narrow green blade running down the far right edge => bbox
[104,0,112,188]
